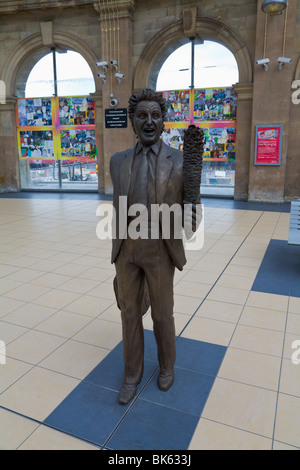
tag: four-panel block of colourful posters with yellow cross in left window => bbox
[16,96,97,162]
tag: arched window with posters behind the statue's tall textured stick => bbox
[156,39,239,196]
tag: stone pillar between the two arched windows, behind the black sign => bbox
[95,0,135,194]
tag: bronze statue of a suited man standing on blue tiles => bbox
[110,90,200,405]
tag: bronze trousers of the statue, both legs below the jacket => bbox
[115,239,176,384]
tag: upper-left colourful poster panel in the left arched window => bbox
[17,98,54,127]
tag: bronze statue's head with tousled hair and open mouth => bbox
[128,89,167,145]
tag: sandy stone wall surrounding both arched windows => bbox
[0,0,300,201]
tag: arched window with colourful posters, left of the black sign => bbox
[17,47,98,191]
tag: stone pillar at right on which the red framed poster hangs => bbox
[248,0,297,202]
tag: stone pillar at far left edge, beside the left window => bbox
[0,96,20,193]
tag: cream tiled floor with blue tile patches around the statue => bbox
[0,194,300,450]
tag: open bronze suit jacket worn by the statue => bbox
[110,142,186,270]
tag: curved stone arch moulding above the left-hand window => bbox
[1,32,102,97]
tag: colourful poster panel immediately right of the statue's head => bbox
[162,90,190,122]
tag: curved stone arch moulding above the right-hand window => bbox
[133,17,253,90]
